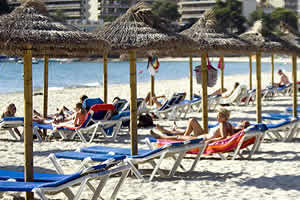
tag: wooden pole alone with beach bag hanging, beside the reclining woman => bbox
[201,53,208,133]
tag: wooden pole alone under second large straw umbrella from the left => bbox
[129,50,138,155]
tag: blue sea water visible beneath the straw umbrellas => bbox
[0,60,300,93]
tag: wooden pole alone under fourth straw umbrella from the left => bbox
[256,52,261,123]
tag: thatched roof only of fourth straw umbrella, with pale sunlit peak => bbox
[240,20,299,54]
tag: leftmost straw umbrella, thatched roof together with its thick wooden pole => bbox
[0,0,109,198]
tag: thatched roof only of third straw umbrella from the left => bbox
[181,9,255,54]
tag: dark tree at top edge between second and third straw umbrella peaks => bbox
[152,0,181,21]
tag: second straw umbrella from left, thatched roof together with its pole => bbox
[99,2,205,154]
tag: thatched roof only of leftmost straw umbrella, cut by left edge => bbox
[0,0,110,57]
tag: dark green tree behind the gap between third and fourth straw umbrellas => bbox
[213,0,246,33]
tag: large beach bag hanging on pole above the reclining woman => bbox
[194,58,218,87]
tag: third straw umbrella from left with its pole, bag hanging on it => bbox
[182,10,255,131]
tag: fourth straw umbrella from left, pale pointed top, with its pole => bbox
[240,21,299,123]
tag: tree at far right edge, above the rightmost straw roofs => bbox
[272,8,298,30]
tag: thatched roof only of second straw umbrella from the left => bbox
[98,2,206,56]
